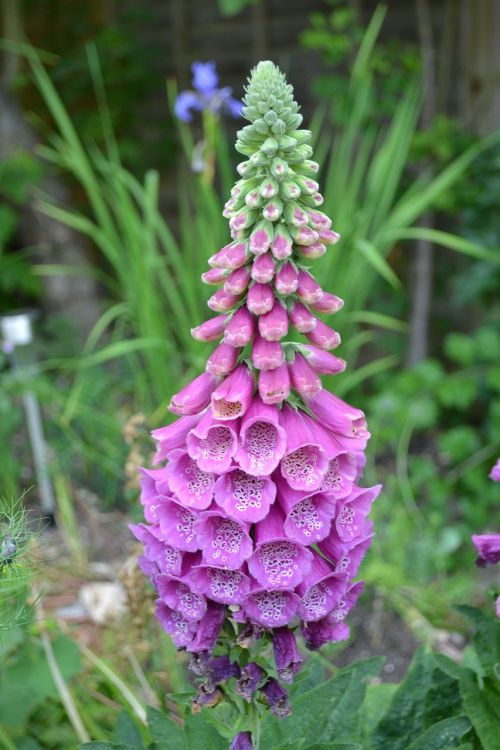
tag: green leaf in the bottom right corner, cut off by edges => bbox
[460,669,500,750]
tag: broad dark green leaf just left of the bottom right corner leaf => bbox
[372,648,460,750]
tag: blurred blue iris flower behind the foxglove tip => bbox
[174,62,242,122]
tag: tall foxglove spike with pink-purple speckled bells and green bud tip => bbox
[131,62,380,748]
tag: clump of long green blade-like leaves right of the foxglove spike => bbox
[313,7,500,390]
